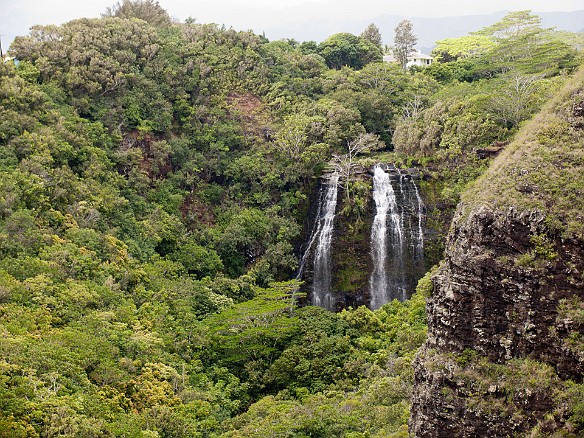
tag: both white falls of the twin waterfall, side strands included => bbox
[297,164,424,311]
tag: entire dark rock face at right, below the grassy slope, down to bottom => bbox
[410,206,584,437]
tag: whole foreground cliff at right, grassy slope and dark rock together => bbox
[410,68,584,437]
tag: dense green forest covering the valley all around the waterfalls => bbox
[0,1,581,437]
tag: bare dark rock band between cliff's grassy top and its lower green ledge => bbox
[427,207,584,379]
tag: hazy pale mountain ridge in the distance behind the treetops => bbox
[264,10,584,51]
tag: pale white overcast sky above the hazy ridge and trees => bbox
[0,0,584,50]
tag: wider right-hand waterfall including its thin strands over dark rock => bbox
[369,165,425,309]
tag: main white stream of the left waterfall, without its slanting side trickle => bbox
[311,172,339,310]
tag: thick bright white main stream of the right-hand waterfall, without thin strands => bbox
[369,165,403,309]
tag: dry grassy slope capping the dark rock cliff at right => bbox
[462,63,584,239]
